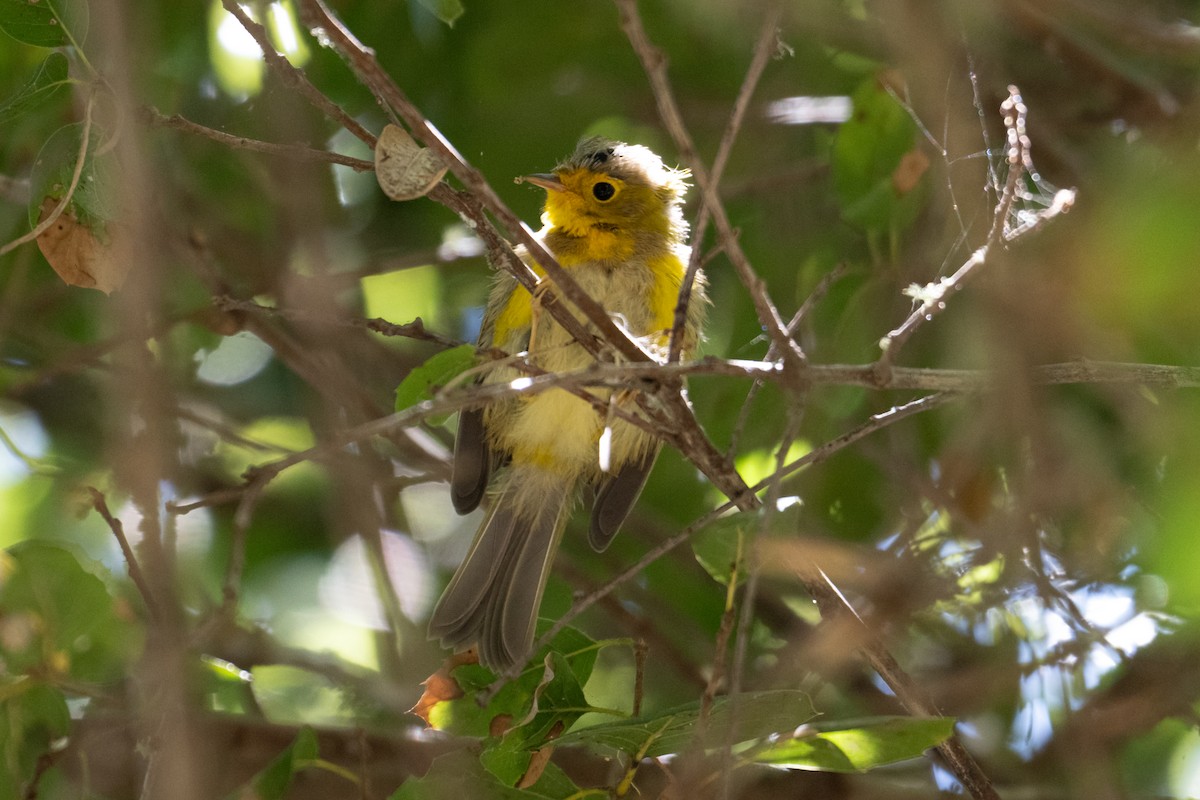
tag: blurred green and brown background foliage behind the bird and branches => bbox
[0,0,1200,799]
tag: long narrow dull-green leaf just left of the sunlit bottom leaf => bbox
[558,690,816,758]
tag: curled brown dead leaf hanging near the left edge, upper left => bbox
[37,197,132,294]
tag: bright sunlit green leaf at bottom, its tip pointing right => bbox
[754,717,955,772]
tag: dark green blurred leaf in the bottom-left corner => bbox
[0,679,71,800]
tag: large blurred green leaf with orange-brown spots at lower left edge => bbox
[0,540,142,684]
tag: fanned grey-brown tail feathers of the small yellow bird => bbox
[430,464,574,669]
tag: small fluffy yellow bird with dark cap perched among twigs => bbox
[430,138,707,669]
